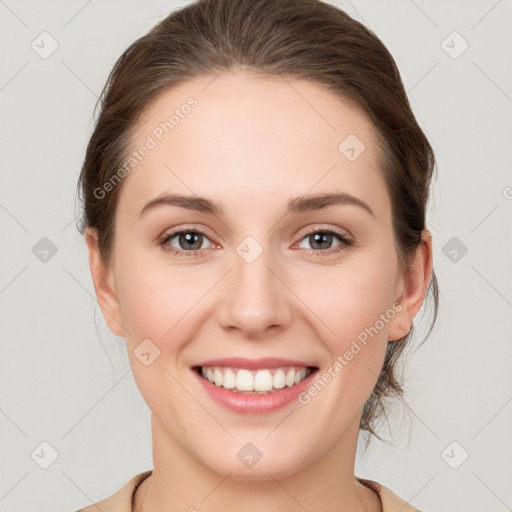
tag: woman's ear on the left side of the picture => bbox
[85,227,125,337]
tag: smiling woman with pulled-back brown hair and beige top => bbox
[75,0,437,512]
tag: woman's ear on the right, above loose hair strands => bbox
[388,229,432,341]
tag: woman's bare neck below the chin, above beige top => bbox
[133,416,381,512]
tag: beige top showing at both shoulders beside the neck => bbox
[76,470,420,512]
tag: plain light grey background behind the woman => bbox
[0,0,512,512]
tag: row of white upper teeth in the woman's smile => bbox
[201,366,310,392]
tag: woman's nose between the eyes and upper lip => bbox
[217,243,294,340]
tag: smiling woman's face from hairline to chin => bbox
[88,72,419,479]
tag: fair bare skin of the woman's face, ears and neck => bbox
[86,70,432,512]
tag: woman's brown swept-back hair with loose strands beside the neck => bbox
[78,0,439,438]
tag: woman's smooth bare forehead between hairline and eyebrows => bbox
[121,71,387,218]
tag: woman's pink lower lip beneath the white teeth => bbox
[192,370,317,414]
